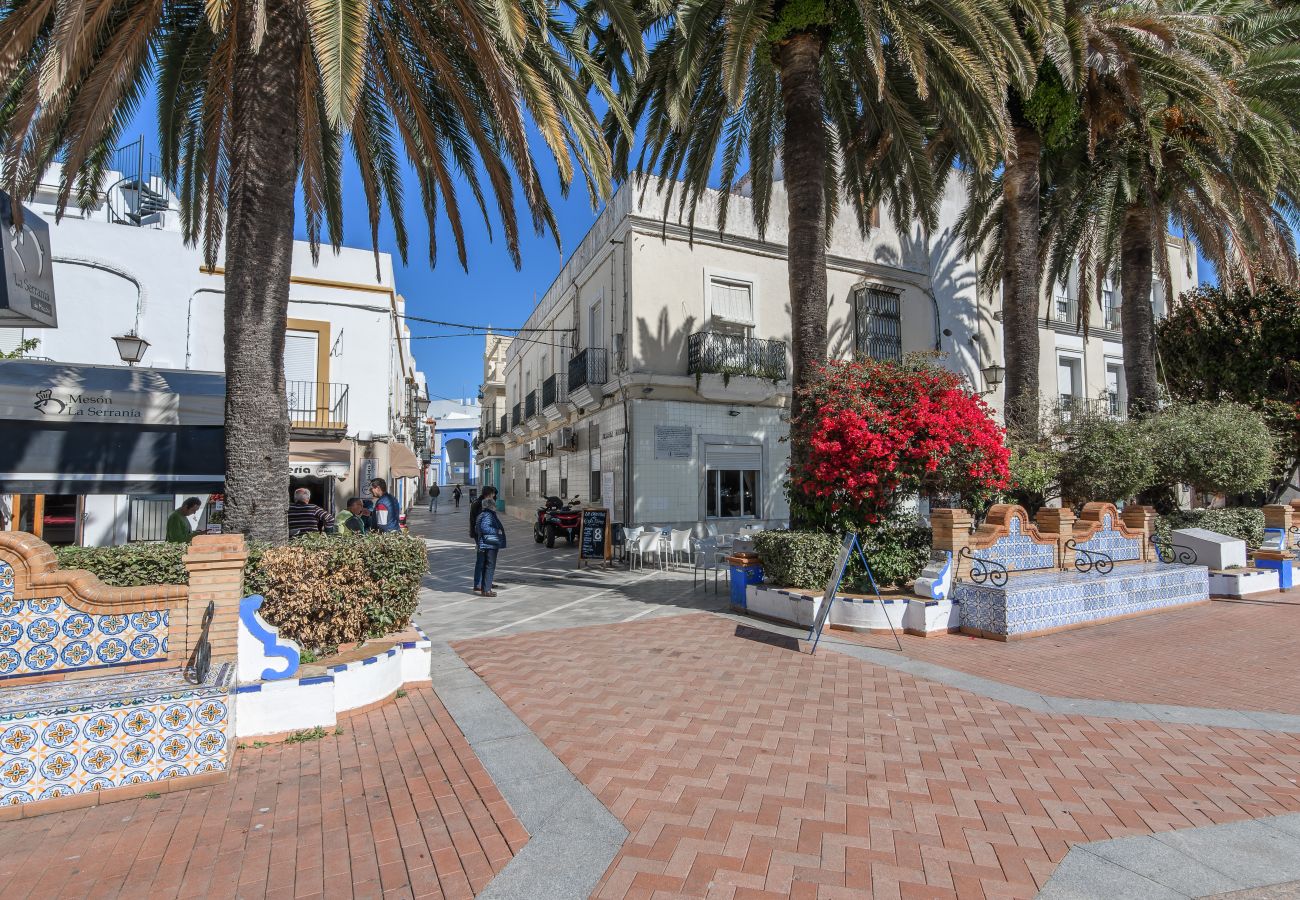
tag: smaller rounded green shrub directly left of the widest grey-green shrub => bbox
[1060,411,1156,503]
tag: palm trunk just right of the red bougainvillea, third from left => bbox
[989,126,1043,438]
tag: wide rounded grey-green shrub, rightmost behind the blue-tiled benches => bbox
[1143,402,1277,494]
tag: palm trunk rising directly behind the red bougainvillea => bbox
[777,33,827,512]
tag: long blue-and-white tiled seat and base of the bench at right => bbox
[953,563,1209,636]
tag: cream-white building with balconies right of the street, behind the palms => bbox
[493,176,1196,529]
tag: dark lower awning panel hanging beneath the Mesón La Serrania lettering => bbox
[0,421,226,494]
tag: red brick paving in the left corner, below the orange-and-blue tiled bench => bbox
[0,688,528,900]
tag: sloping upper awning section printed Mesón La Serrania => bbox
[0,359,226,427]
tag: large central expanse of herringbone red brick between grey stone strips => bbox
[456,615,1300,900]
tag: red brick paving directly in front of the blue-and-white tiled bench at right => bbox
[828,588,1300,715]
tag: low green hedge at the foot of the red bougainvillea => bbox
[754,522,931,593]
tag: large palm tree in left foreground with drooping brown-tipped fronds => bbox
[0,0,636,540]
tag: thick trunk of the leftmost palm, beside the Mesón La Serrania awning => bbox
[225,0,303,541]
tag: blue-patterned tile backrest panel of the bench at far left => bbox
[0,559,169,679]
